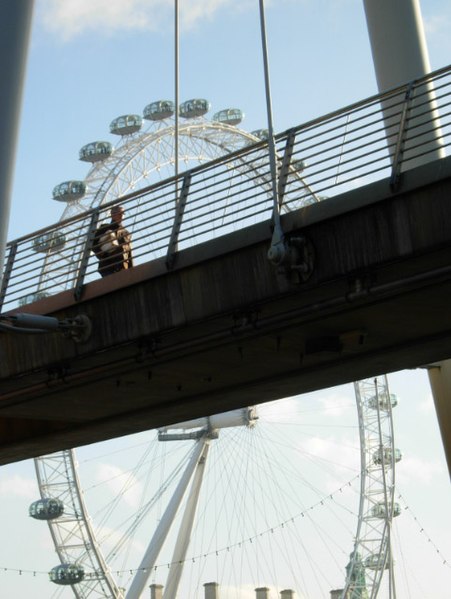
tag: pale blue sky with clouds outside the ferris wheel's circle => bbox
[0,0,451,599]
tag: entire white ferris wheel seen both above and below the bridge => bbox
[30,99,401,599]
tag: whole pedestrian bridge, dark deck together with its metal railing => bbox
[0,68,451,464]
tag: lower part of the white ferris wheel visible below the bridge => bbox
[30,377,401,599]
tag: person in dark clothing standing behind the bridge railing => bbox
[92,206,133,277]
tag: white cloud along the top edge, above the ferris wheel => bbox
[39,0,252,41]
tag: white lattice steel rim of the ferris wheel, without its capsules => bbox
[35,113,400,599]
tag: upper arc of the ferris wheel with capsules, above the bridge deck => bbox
[29,98,318,303]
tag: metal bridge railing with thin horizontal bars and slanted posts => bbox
[0,67,451,310]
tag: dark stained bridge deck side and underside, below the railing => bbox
[0,159,451,464]
